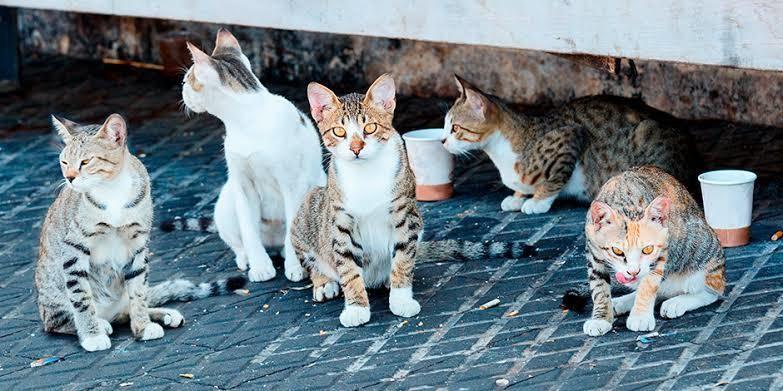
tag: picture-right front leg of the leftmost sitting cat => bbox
[125,250,163,341]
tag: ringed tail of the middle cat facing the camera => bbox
[416,239,536,262]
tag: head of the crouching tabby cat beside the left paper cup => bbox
[442,75,496,154]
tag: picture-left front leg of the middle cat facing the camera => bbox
[331,208,370,327]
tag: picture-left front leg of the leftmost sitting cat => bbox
[63,248,111,352]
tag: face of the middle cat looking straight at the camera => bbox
[307,74,396,162]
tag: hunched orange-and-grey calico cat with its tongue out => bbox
[563,166,726,336]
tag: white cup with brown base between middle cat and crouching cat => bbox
[402,129,454,201]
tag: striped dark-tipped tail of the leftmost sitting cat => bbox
[147,276,247,307]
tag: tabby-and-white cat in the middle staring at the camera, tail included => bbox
[291,74,544,327]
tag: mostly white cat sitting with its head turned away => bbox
[173,28,326,281]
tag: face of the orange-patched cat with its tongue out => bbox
[586,196,670,284]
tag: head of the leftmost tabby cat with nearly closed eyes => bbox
[52,114,127,192]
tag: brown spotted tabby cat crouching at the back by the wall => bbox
[443,76,689,214]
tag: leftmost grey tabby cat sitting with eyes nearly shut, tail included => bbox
[35,114,245,351]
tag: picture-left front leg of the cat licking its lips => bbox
[582,253,614,337]
